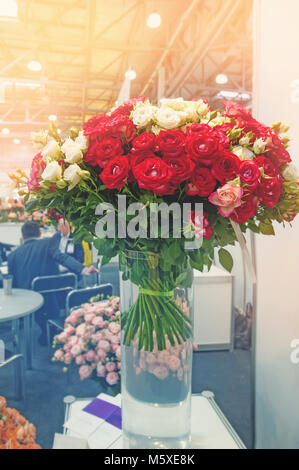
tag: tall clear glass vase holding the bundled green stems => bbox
[120,251,193,449]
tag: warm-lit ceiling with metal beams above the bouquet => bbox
[0,0,252,138]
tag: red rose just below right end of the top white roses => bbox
[186,124,224,166]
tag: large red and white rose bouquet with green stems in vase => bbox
[15,96,299,350]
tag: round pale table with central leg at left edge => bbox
[0,289,44,369]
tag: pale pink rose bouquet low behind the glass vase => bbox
[52,297,120,393]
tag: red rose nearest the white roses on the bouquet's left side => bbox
[84,137,123,168]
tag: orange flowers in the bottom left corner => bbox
[0,396,41,449]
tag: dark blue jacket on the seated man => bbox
[7,237,84,289]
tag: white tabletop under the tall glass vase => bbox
[63,392,245,449]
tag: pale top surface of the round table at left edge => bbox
[0,289,44,323]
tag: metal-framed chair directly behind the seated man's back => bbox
[31,273,78,352]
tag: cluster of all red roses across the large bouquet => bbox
[84,96,291,223]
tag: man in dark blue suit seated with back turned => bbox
[7,222,97,344]
